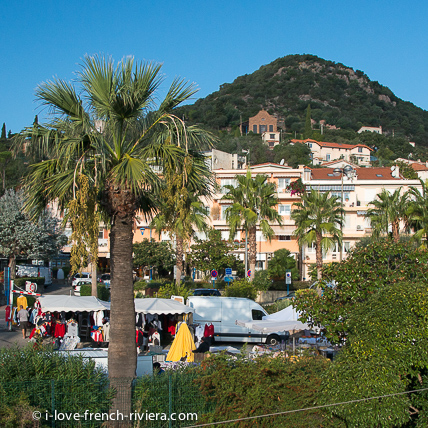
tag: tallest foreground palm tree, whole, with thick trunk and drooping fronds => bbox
[15,56,216,413]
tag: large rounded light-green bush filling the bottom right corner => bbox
[321,281,428,428]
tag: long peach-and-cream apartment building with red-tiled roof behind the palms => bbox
[55,161,421,279]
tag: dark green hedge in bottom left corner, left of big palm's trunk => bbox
[0,344,112,427]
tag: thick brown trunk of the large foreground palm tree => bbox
[108,207,137,426]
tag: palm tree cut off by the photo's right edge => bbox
[406,180,428,248]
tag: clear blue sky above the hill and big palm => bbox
[0,0,428,132]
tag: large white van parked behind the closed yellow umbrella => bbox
[187,296,287,345]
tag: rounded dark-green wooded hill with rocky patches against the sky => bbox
[181,55,428,146]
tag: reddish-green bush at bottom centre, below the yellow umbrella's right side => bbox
[198,355,345,428]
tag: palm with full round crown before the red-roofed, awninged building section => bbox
[291,190,343,281]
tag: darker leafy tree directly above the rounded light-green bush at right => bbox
[295,239,428,343]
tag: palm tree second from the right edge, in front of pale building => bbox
[366,187,408,242]
